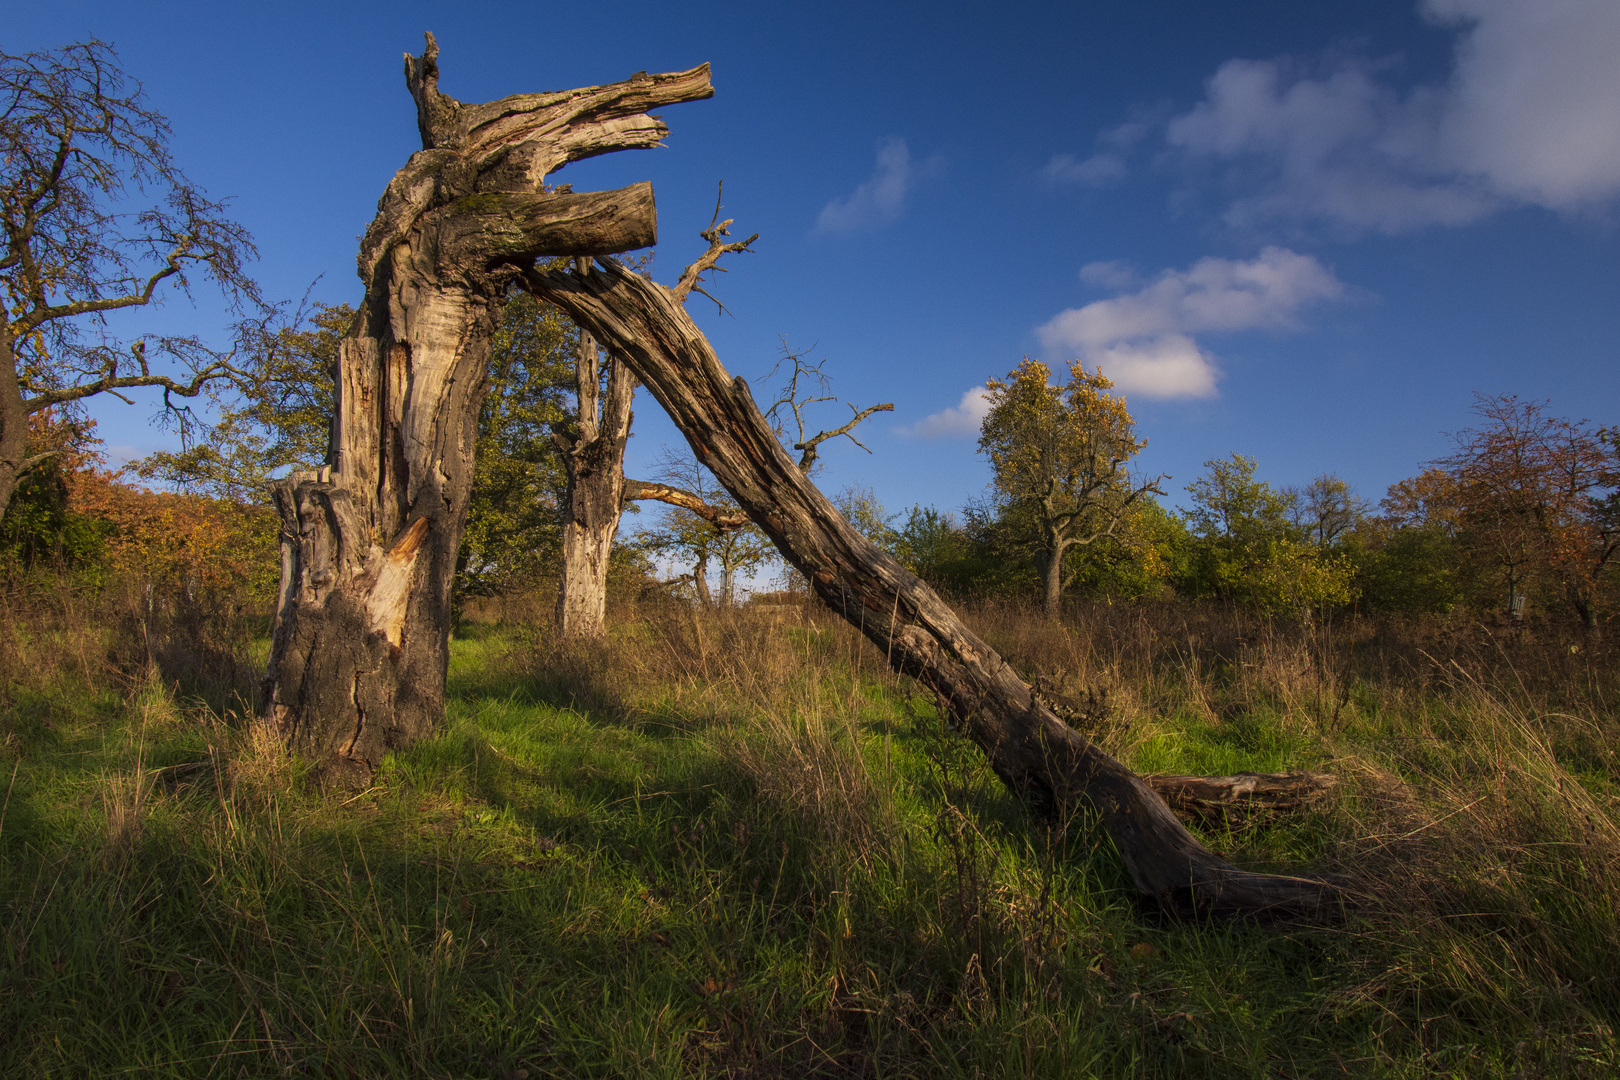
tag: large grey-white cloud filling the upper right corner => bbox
[1146,0,1620,233]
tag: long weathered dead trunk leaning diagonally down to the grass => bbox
[528,259,1341,916]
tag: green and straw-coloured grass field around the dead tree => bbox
[0,601,1620,1078]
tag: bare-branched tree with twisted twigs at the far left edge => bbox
[0,40,259,515]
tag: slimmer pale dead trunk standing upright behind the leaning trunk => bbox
[557,330,635,638]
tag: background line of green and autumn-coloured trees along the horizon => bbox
[0,298,1620,630]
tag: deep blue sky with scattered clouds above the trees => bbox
[15,0,1620,524]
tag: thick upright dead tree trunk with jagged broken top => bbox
[264,34,713,785]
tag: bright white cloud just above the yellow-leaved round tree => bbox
[1037,248,1345,398]
